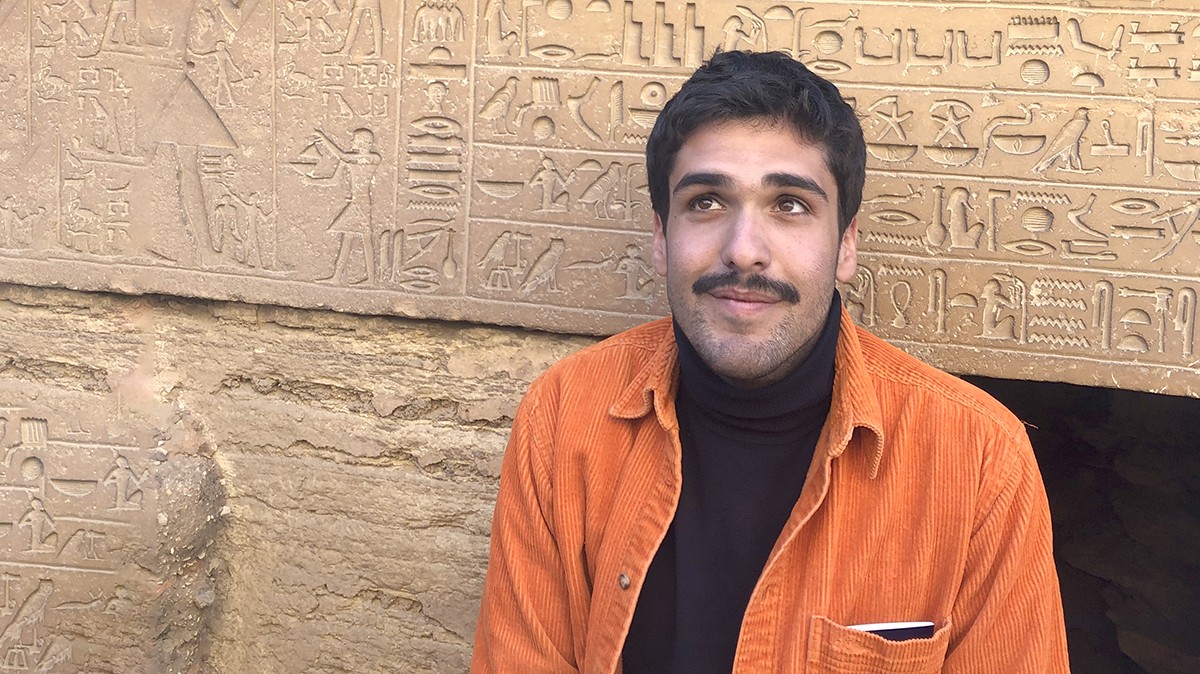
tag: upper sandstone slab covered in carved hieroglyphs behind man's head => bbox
[0,0,1200,393]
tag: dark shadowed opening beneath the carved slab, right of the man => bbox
[965,377,1200,674]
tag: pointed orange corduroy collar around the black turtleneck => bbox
[608,308,884,479]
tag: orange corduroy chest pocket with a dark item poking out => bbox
[805,615,950,674]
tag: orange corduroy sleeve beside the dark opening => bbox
[942,429,1069,674]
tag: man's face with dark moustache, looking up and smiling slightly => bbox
[654,120,858,386]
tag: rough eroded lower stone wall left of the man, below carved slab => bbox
[0,280,590,674]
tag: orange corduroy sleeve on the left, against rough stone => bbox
[470,383,577,674]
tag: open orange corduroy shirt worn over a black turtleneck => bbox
[472,313,1068,674]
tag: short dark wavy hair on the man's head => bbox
[646,50,866,231]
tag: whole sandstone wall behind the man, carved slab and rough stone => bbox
[0,0,1200,673]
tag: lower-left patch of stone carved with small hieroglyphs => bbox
[0,405,157,674]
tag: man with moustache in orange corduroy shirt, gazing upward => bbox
[473,52,1067,674]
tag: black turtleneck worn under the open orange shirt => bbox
[623,293,841,674]
